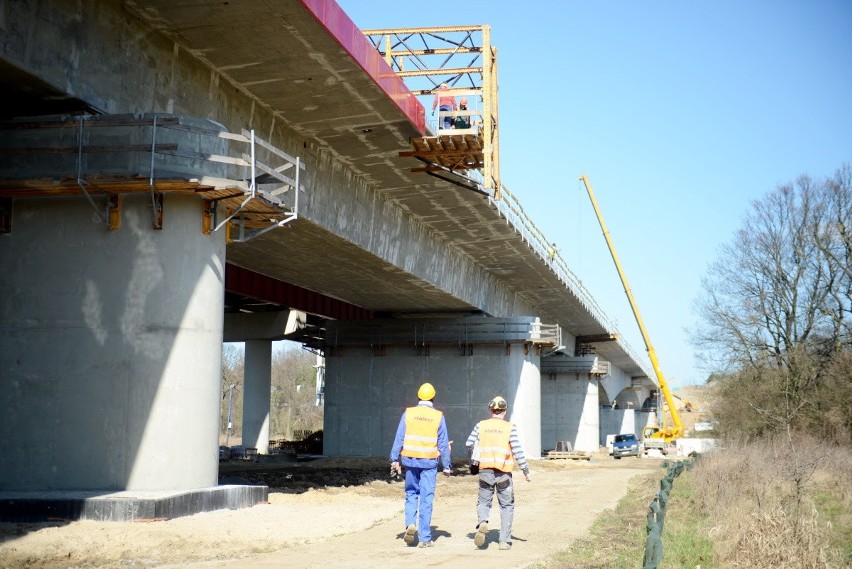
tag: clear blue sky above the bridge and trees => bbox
[338,0,852,387]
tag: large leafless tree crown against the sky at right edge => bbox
[693,165,852,440]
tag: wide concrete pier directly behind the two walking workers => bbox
[324,318,541,458]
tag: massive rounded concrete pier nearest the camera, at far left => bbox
[0,194,225,491]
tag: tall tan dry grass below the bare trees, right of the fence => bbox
[693,437,852,569]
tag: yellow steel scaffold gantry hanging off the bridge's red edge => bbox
[363,26,502,200]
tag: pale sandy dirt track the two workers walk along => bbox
[0,455,662,569]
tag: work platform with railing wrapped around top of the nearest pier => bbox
[0,114,305,242]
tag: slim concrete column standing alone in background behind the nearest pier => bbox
[243,340,272,454]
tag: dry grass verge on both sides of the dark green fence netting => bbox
[535,437,852,569]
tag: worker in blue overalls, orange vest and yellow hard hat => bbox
[390,383,452,547]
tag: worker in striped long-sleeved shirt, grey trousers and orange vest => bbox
[465,395,532,549]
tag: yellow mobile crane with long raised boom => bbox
[580,175,683,454]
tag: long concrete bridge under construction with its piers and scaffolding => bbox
[0,0,655,519]
